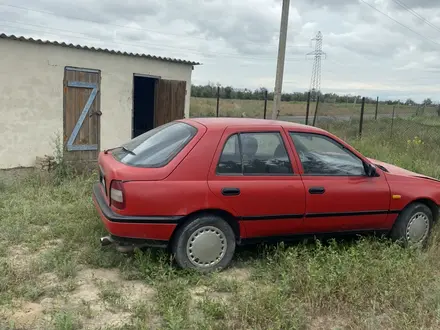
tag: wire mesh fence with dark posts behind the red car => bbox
[191,92,440,151]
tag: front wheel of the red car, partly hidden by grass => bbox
[391,203,433,247]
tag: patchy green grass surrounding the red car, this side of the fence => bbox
[0,120,440,330]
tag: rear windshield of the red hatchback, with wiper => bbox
[113,122,197,167]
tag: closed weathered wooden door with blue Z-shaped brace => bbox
[64,67,101,162]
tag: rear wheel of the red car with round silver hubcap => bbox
[171,215,236,273]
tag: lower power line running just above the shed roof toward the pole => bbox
[0,22,301,62]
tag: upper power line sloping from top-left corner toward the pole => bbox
[0,4,308,48]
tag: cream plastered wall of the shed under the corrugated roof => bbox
[0,39,192,168]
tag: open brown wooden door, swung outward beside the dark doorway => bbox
[154,79,186,127]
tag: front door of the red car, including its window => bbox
[289,131,391,232]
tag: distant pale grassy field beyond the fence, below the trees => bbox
[190,97,436,118]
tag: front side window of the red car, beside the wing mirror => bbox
[289,132,366,176]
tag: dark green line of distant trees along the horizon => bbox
[191,84,434,106]
